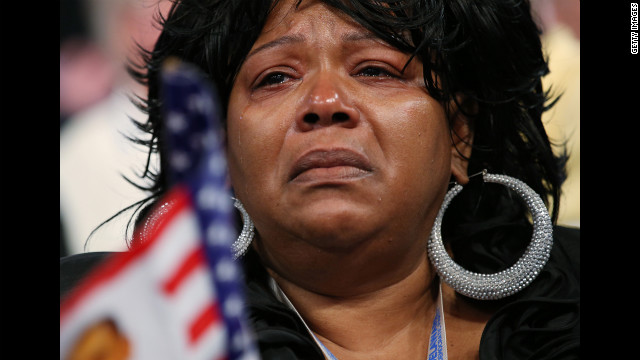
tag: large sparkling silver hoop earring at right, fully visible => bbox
[427,170,553,300]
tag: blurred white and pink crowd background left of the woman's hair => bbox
[60,0,168,256]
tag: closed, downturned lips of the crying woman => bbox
[289,149,372,182]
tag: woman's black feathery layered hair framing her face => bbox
[124,0,566,271]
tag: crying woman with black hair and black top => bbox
[110,0,579,360]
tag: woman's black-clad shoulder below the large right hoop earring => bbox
[480,227,580,360]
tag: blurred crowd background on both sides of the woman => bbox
[60,0,580,256]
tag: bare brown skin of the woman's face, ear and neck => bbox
[227,1,479,359]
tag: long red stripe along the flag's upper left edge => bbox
[60,187,190,327]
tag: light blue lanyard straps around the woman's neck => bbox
[270,278,448,360]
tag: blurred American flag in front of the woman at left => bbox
[60,60,259,360]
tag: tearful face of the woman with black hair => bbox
[227,1,468,278]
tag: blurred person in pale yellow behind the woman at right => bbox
[531,0,580,227]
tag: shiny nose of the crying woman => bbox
[297,73,360,131]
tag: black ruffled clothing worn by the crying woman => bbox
[60,227,580,360]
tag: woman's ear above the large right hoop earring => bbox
[449,97,477,185]
